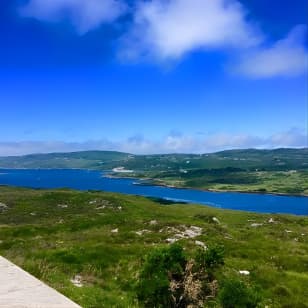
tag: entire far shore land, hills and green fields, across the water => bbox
[0,148,308,195]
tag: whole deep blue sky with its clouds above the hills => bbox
[0,0,308,155]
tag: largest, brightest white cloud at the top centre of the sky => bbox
[120,0,262,60]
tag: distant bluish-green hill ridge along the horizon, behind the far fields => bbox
[0,148,308,172]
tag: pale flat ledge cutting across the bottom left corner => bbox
[0,256,81,308]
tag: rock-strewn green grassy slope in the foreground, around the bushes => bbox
[0,187,308,308]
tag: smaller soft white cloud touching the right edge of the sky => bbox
[236,26,308,78]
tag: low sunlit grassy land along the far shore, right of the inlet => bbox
[139,169,308,196]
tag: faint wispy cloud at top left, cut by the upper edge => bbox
[21,0,127,34]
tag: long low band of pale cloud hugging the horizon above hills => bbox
[0,129,308,156]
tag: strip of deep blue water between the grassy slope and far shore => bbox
[0,169,308,215]
